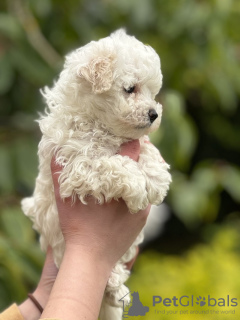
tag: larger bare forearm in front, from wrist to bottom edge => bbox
[42,246,111,320]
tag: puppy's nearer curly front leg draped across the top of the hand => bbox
[57,155,148,213]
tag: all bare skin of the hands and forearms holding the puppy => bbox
[19,140,150,320]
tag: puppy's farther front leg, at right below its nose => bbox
[138,141,171,205]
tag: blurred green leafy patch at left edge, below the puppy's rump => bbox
[0,207,43,310]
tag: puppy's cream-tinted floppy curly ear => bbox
[78,55,114,93]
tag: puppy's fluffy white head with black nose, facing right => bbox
[45,30,162,139]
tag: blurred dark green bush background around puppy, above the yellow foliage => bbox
[0,0,240,307]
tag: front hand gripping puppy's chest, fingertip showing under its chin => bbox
[51,140,150,268]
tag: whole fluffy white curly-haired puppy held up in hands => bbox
[22,30,171,320]
